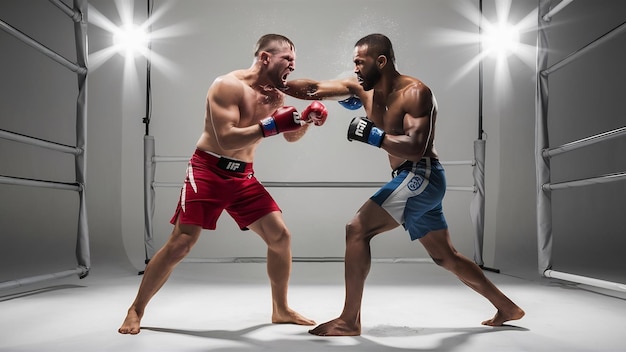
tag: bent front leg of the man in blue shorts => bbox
[309,200,398,336]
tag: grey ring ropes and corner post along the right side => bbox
[535,0,626,292]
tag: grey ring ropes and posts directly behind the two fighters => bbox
[144,135,485,266]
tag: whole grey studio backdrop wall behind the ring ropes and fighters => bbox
[7,0,626,286]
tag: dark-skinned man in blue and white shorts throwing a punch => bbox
[285,34,524,336]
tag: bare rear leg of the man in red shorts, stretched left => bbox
[118,222,202,335]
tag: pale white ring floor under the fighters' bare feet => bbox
[0,263,626,352]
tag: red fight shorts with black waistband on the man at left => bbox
[170,149,280,230]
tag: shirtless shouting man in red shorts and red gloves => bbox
[118,34,327,334]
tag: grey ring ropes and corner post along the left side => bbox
[0,0,91,290]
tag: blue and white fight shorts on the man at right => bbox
[370,158,448,240]
